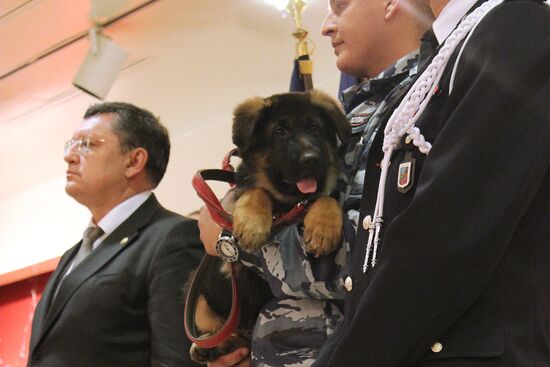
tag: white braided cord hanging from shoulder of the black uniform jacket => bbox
[363,0,504,273]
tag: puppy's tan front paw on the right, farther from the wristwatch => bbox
[304,197,343,257]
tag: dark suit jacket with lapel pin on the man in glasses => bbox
[27,195,203,367]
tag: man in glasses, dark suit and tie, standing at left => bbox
[27,103,203,367]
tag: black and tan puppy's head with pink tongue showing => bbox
[233,91,351,202]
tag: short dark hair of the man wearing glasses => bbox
[84,102,170,187]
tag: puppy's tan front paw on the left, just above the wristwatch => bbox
[233,188,273,251]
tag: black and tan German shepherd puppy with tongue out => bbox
[191,91,351,363]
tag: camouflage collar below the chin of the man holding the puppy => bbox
[342,50,418,110]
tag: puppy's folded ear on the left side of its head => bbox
[233,97,269,153]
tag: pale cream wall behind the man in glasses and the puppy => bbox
[0,0,339,274]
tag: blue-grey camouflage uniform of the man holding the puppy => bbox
[242,51,418,367]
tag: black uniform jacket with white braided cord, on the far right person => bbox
[324,0,550,367]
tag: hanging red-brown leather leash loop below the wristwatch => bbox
[185,254,240,348]
